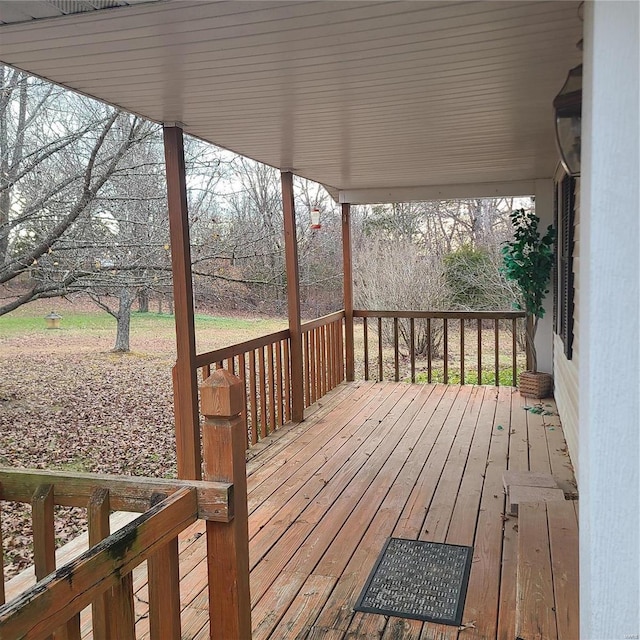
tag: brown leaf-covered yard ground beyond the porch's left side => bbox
[0,301,282,578]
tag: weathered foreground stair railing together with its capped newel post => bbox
[0,372,251,640]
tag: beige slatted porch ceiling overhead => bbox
[0,0,581,201]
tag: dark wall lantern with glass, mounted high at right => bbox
[553,64,582,176]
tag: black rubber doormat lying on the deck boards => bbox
[354,538,473,626]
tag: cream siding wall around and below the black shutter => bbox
[553,179,580,477]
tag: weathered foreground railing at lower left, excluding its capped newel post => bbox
[0,468,233,640]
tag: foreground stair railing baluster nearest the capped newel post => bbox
[148,492,180,640]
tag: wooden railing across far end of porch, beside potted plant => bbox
[353,310,526,386]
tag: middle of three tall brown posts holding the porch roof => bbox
[281,171,304,422]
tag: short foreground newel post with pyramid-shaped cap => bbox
[200,369,251,640]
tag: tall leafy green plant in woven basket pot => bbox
[502,209,555,398]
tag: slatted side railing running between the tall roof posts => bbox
[196,311,344,446]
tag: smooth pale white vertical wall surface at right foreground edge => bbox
[579,0,640,640]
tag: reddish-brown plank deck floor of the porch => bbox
[10,383,578,640]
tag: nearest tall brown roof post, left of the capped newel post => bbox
[164,126,202,480]
